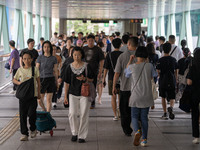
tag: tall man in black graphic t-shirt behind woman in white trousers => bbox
[83,35,104,109]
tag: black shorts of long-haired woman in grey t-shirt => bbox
[40,77,56,94]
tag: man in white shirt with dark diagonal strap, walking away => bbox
[162,35,184,61]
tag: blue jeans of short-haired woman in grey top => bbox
[131,107,149,139]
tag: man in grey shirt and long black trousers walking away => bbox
[112,37,138,136]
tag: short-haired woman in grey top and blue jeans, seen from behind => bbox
[125,46,154,146]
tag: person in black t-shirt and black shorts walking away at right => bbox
[156,43,178,120]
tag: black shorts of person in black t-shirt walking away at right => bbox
[159,88,176,100]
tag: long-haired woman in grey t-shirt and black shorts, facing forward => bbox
[36,41,58,112]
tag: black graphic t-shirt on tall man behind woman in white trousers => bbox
[83,46,104,75]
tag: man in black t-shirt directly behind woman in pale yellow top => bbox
[20,38,39,67]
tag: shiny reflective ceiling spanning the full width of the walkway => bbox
[0,0,200,19]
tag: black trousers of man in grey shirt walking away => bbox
[119,91,133,134]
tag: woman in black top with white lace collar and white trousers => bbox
[64,47,94,143]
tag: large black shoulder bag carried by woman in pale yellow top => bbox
[16,67,34,100]
